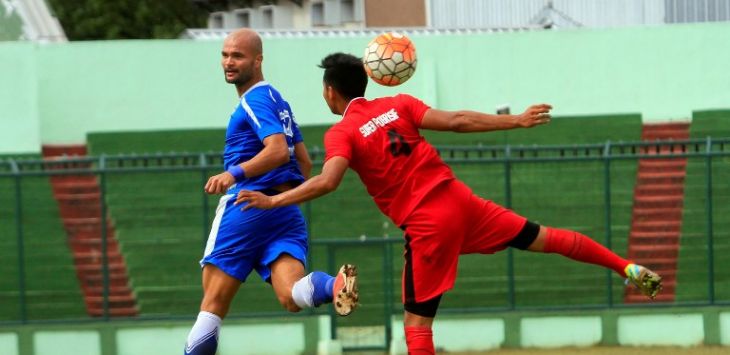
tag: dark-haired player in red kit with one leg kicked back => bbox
[236,53,661,354]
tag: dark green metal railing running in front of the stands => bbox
[0,138,730,344]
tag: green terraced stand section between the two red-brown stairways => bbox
[88,115,641,324]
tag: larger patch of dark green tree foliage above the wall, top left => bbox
[49,0,207,40]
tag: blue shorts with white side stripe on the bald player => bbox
[200,194,307,282]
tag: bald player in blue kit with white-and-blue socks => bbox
[185,29,358,355]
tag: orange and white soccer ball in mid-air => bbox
[362,32,417,86]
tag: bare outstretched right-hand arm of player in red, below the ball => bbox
[421,104,552,132]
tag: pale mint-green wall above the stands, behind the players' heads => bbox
[0,23,730,153]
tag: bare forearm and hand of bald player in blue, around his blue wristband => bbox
[205,134,289,195]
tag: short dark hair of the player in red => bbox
[319,53,368,99]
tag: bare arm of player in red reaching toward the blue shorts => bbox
[235,157,350,210]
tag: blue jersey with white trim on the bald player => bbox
[223,81,304,193]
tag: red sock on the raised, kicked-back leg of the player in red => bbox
[544,227,630,277]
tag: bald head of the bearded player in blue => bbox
[221,28,264,87]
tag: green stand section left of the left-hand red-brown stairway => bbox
[0,156,86,321]
